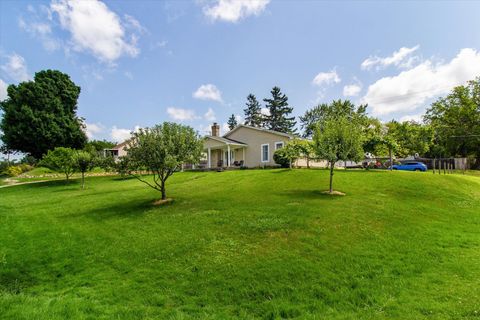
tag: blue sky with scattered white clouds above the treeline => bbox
[0,0,480,141]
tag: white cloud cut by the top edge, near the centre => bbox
[203,0,270,23]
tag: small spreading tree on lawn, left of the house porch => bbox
[126,122,203,200]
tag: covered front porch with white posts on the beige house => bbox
[204,136,247,169]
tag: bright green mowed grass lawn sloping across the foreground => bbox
[0,170,480,319]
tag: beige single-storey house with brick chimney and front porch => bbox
[203,123,294,168]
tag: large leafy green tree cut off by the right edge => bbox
[425,78,480,157]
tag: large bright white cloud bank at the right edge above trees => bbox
[362,48,480,116]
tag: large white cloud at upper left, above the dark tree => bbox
[50,0,140,63]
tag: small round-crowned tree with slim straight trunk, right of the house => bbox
[313,117,363,193]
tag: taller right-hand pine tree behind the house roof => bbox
[263,87,297,133]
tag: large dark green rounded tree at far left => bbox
[0,70,87,159]
